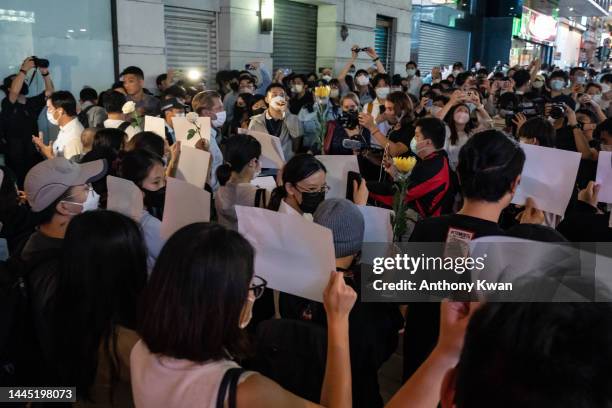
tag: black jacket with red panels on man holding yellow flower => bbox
[370,150,454,217]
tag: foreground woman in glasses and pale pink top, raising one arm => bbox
[130,223,356,408]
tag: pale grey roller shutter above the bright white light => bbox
[164,6,217,82]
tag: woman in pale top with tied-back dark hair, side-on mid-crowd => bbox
[215,134,268,231]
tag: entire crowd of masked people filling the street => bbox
[0,46,612,408]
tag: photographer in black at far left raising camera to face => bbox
[0,57,54,186]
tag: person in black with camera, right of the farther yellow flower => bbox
[325,92,371,155]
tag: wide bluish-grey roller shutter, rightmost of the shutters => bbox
[418,21,471,71]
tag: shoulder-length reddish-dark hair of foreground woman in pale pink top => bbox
[140,223,255,362]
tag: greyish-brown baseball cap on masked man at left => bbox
[24,157,107,212]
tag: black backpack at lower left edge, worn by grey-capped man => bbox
[0,251,56,386]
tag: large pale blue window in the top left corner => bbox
[0,0,114,99]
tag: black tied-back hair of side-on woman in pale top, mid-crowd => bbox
[217,135,261,186]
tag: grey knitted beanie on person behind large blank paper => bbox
[313,198,364,258]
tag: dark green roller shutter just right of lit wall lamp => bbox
[272,0,317,74]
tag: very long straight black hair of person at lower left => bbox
[52,210,147,399]
